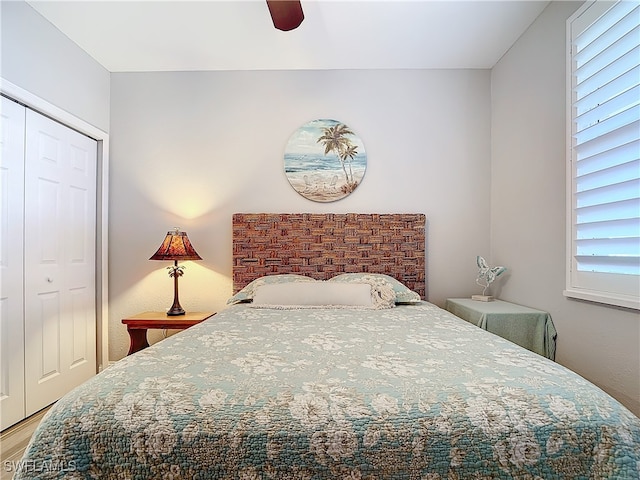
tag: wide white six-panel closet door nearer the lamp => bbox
[24,110,97,415]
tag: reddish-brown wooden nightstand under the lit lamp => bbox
[122,312,215,355]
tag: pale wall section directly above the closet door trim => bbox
[0,1,110,132]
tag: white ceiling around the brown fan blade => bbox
[28,0,549,72]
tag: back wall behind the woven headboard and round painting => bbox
[109,70,490,359]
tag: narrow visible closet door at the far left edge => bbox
[0,97,25,430]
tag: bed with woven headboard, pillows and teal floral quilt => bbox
[16,214,640,480]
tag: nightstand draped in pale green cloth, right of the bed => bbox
[445,298,557,360]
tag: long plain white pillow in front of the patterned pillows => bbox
[253,282,373,308]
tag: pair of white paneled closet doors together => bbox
[0,97,98,430]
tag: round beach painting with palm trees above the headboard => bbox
[284,119,367,202]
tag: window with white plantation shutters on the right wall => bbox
[565,0,640,309]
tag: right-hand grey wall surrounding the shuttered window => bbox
[491,2,640,415]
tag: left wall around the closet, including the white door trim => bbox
[0,1,110,367]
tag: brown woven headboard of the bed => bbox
[233,213,426,299]
